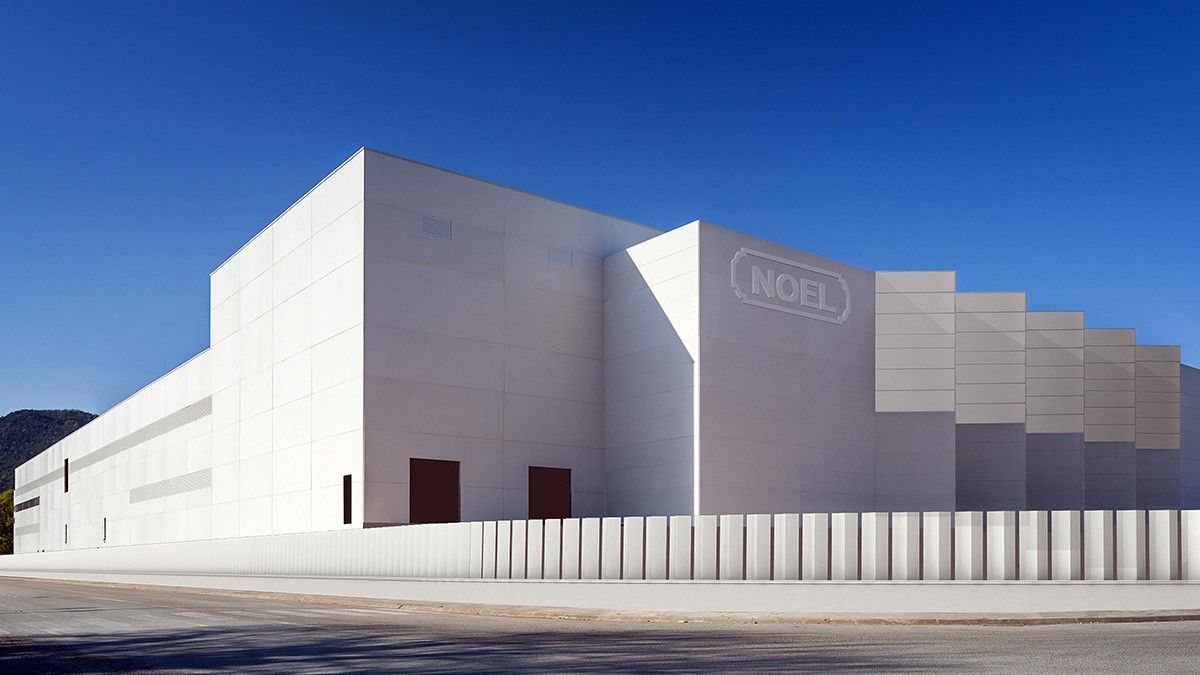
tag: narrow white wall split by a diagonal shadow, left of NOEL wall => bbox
[604,222,701,515]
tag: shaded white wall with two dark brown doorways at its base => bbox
[364,150,658,524]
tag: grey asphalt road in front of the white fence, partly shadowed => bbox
[0,578,1200,673]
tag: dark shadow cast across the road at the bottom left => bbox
[0,625,953,673]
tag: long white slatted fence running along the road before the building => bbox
[7,510,1200,581]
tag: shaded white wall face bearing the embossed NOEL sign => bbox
[697,223,875,514]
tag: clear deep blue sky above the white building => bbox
[0,1,1200,413]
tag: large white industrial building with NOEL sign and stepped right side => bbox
[14,149,1200,552]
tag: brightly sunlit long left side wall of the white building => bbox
[17,151,364,550]
